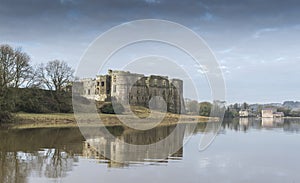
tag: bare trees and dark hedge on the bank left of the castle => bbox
[0,44,74,122]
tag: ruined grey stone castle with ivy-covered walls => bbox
[73,70,185,114]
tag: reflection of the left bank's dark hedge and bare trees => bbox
[0,129,82,182]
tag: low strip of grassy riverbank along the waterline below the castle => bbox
[5,113,218,129]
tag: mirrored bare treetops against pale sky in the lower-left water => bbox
[0,149,78,182]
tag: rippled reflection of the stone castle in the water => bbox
[82,125,199,167]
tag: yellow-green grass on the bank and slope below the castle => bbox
[11,107,217,129]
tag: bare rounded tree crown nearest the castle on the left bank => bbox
[38,60,74,91]
